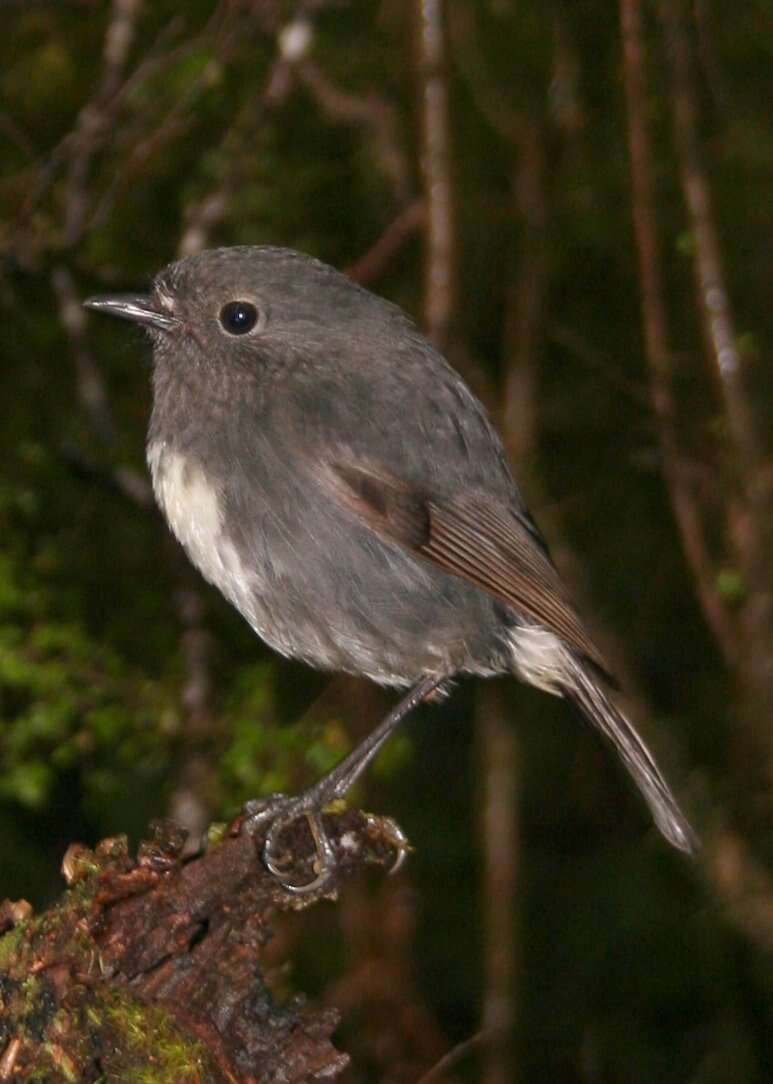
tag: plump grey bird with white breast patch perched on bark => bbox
[85,245,696,893]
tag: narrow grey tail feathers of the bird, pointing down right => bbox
[562,651,697,854]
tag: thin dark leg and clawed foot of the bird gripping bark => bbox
[244,674,447,894]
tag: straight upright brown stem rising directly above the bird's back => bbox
[417,0,455,348]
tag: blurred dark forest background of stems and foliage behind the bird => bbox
[0,0,773,1084]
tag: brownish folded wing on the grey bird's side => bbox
[320,453,608,674]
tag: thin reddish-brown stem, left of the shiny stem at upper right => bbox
[620,0,737,667]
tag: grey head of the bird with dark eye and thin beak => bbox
[85,246,410,377]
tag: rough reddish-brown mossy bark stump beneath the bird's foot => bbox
[0,811,407,1084]
